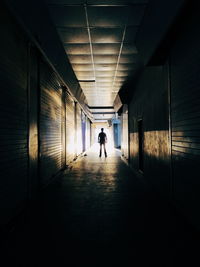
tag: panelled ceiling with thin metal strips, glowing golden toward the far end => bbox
[46,0,148,120]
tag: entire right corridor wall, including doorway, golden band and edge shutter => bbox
[129,1,200,229]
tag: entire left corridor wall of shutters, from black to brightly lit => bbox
[0,2,90,227]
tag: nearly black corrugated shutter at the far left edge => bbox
[0,3,28,224]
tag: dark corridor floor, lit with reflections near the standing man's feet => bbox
[5,147,200,267]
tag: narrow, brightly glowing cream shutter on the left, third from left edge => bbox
[66,93,75,164]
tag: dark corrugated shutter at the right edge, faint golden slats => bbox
[171,9,200,222]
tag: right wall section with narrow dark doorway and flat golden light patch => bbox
[129,67,170,196]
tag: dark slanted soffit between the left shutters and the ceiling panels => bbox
[3,0,88,112]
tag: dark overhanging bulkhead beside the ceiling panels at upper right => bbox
[136,0,186,65]
